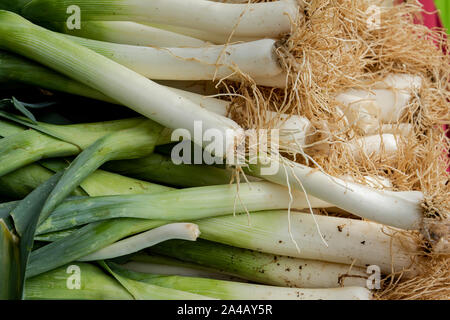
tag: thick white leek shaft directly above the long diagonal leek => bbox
[68,36,286,86]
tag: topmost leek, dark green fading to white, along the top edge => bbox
[22,0,299,38]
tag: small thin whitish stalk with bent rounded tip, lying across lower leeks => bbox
[78,223,200,261]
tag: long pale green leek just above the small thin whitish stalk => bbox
[37,182,329,234]
